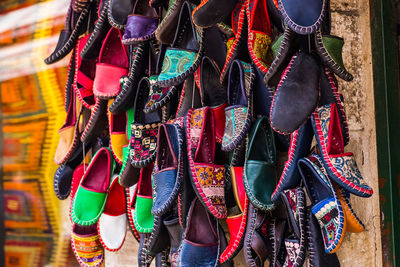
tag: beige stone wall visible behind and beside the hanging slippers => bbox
[102,0,382,267]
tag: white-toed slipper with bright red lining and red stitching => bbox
[97,175,128,251]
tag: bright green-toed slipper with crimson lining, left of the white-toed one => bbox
[71,147,115,225]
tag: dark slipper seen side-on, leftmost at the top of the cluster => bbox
[44,2,91,65]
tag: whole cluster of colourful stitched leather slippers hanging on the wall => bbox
[45,0,372,266]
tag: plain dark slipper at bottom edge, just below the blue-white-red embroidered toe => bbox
[306,207,340,267]
